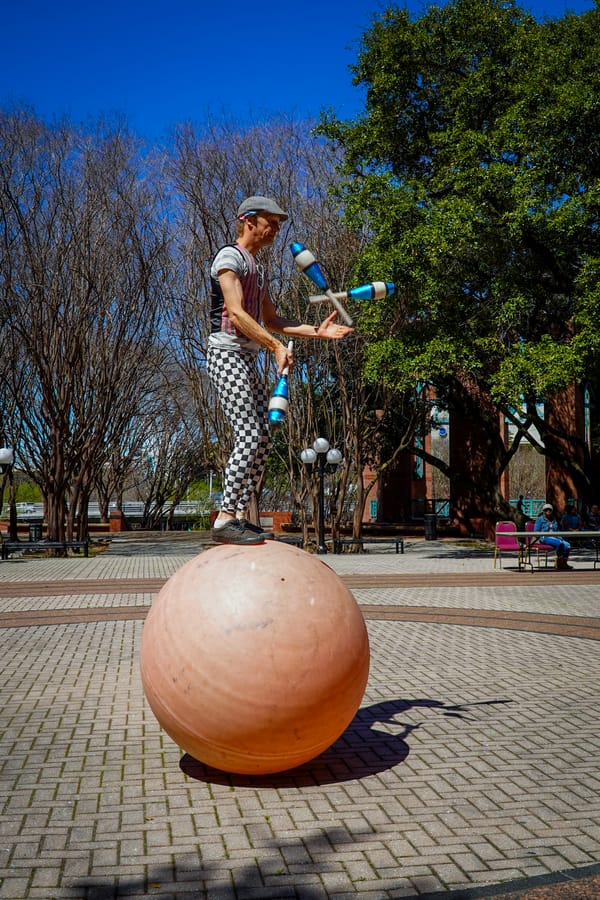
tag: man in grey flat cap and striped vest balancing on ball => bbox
[207,196,353,544]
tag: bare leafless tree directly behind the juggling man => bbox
[173,119,357,532]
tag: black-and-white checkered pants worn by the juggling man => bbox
[206,346,271,515]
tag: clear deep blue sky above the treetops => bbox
[0,0,593,140]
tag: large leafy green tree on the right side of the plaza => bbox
[321,0,600,524]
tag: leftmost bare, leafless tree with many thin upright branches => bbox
[0,112,169,539]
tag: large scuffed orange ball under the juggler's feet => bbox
[140,541,369,774]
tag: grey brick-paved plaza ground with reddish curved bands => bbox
[0,540,600,900]
